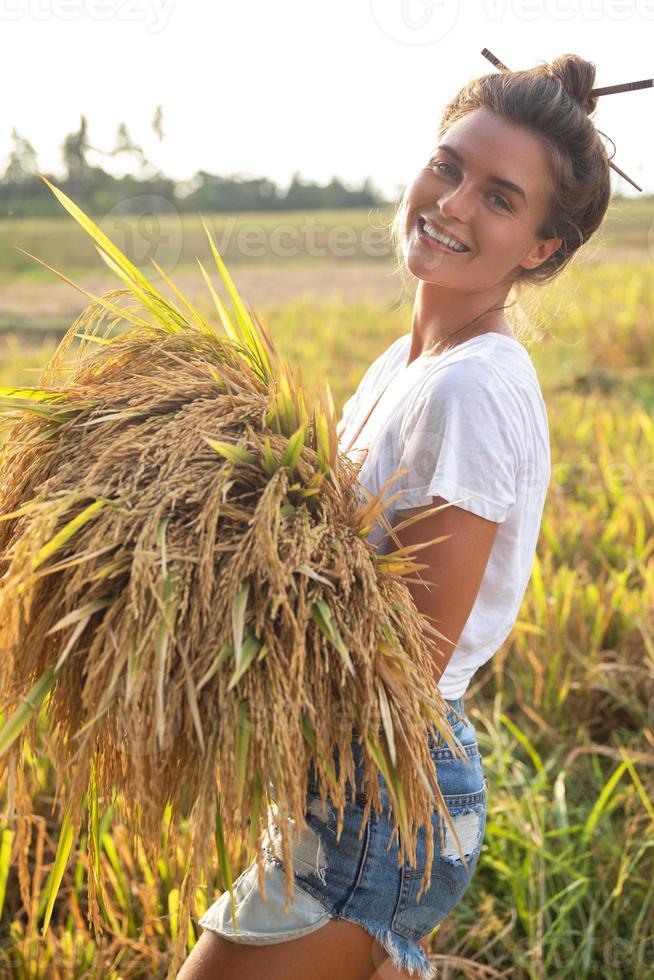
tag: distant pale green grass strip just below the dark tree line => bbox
[0,197,654,285]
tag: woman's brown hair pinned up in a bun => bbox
[389,54,611,320]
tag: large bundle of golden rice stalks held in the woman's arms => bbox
[0,178,466,976]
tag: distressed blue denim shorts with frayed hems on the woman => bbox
[199,697,486,980]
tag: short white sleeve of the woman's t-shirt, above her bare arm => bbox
[391,358,522,523]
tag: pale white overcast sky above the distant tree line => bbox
[0,0,654,199]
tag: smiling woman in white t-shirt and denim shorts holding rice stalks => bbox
[179,55,610,980]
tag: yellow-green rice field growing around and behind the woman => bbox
[0,211,654,980]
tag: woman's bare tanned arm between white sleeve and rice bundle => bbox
[396,497,500,681]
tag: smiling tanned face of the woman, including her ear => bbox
[403,109,561,292]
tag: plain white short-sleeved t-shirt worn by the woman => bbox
[339,332,551,700]
